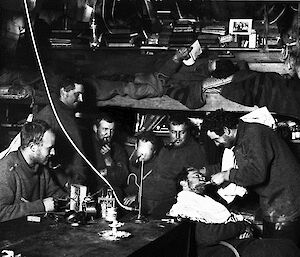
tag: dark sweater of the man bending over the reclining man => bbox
[207,121,300,222]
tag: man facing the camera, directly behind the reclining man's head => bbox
[151,115,207,214]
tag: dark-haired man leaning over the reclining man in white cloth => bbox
[200,110,300,246]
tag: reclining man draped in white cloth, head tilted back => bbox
[169,168,300,257]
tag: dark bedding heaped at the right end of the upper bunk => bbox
[221,70,300,119]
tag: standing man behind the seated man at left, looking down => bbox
[35,77,87,190]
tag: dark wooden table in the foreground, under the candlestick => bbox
[0,214,191,257]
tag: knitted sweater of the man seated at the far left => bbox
[0,151,66,221]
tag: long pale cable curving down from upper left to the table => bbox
[23,0,136,211]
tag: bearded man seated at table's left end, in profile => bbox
[0,120,67,222]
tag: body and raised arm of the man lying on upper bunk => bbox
[85,47,207,108]
